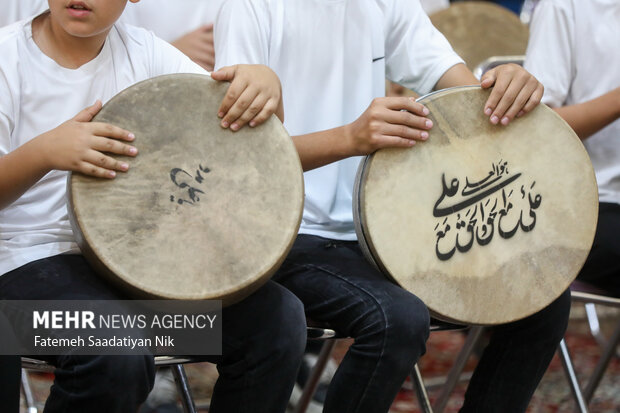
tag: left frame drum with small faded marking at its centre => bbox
[68,74,303,305]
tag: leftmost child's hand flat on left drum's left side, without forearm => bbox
[37,101,138,178]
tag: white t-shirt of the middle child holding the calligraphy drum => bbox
[215,0,462,240]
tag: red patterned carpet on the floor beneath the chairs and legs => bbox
[21,305,620,413]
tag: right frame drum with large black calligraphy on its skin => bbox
[354,86,598,325]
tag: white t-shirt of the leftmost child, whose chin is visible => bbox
[0,20,207,274]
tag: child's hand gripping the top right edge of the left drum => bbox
[211,65,283,131]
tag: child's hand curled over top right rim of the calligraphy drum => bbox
[480,64,544,125]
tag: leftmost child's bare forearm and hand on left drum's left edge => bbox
[0,101,137,209]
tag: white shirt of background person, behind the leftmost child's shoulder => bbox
[120,0,224,42]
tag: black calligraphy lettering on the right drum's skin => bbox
[433,160,542,261]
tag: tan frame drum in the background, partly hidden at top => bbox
[430,1,529,70]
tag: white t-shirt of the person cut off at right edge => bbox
[524,0,620,203]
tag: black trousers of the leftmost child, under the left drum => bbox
[0,255,306,413]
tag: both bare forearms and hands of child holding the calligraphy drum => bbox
[293,64,543,171]
